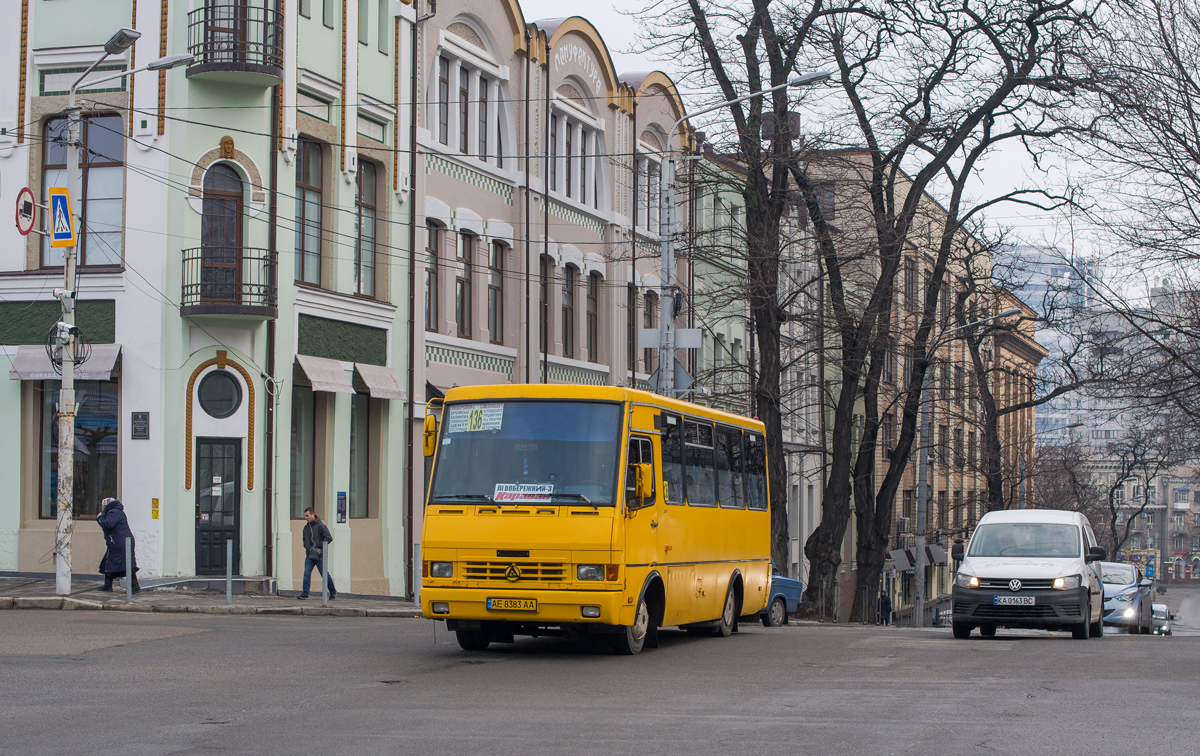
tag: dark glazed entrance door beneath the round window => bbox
[196,438,241,575]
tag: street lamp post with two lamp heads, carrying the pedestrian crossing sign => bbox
[52,29,192,595]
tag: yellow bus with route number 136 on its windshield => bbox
[420,385,770,654]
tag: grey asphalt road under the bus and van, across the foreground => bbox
[0,602,1200,756]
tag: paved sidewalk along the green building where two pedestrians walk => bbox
[0,577,421,618]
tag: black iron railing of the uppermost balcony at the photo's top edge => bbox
[187,0,283,86]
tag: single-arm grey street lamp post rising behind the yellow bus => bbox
[659,71,833,397]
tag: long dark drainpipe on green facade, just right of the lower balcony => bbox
[264,84,280,577]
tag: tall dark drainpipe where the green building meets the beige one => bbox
[408,0,438,599]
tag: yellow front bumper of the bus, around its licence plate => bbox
[421,586,634,626]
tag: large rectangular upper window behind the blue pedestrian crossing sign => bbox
[42,115,125,266]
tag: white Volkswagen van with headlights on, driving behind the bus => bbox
[952,509,1108,640]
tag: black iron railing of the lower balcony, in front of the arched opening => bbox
[179,246,280,319]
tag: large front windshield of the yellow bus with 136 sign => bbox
[430,401,622,506]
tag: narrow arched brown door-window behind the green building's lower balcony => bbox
[200,163,242,302]
